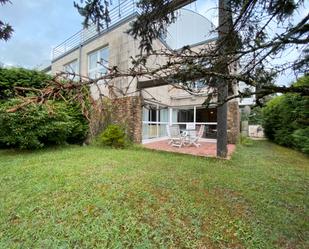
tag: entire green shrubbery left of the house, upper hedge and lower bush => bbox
[0,68,88,149]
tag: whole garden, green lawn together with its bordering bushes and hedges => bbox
[0,69,309,248]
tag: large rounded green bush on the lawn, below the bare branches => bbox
[0,99,88,149]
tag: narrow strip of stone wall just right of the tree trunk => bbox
[227,101,240,144]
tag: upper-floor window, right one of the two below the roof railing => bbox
[88,47,109,79]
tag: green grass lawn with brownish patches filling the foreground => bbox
[0,141,309,249]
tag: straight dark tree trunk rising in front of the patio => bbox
[217,0,232,158]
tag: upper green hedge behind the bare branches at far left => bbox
[0,68,51,100]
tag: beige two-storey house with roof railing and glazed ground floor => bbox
[51,0,239,143]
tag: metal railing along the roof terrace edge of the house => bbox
[52,0,137,60]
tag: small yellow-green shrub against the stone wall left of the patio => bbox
[99,125,128,148]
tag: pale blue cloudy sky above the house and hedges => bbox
[0,0,302,83]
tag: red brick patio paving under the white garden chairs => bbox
[143,140,236,157]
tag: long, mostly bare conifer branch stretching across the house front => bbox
[8,43,309,116]
